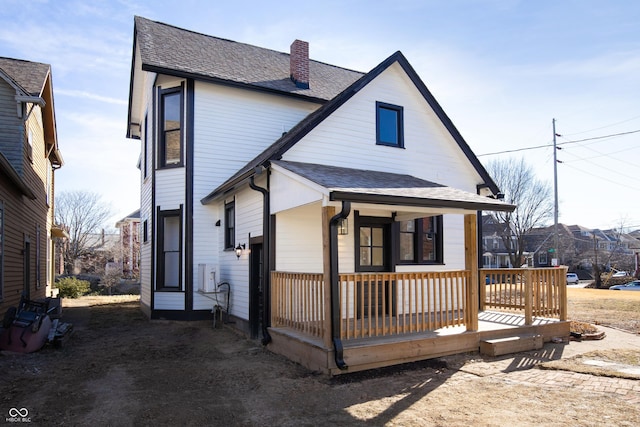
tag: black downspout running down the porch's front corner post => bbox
[329,200,351,370]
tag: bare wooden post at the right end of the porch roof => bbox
[464,213,479,331]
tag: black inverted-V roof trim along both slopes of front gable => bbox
[201,51,499,204]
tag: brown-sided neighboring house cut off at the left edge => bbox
[0,58,63,313]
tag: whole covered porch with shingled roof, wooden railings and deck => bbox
[265,161,569,375]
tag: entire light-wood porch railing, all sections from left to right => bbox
[271,267,567,343]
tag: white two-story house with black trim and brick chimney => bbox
[127,17,568,373]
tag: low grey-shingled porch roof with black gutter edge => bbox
[272,160,515,212]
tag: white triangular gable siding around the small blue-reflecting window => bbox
[282,64,480,193]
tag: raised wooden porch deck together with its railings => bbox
[269,268,570,375]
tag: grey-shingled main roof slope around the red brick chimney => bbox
[135,16,363,100]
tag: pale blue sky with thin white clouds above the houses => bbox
[0,0,640,229]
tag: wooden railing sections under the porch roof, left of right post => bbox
[271,270,469,340]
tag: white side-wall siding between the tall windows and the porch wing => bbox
[190,82,318,319]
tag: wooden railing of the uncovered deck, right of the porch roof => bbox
[479,267,567,325]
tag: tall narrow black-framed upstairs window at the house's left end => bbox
[158,87,183,168]
